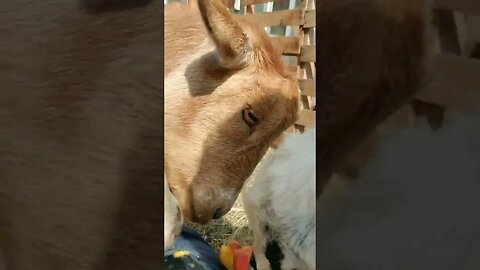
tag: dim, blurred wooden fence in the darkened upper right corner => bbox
[388,0,480,129]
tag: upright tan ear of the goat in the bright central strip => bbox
[197,0,250,68]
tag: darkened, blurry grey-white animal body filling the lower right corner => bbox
[316,108,480,270]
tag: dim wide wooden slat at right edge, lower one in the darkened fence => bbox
[417,55,480,113]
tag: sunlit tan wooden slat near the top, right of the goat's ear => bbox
[237,8,304,27]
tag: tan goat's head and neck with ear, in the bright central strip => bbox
[164,0,299,223]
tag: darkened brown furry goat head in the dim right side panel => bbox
[316,0,429,195]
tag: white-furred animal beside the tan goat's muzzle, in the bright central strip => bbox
[242,129,315,270]
